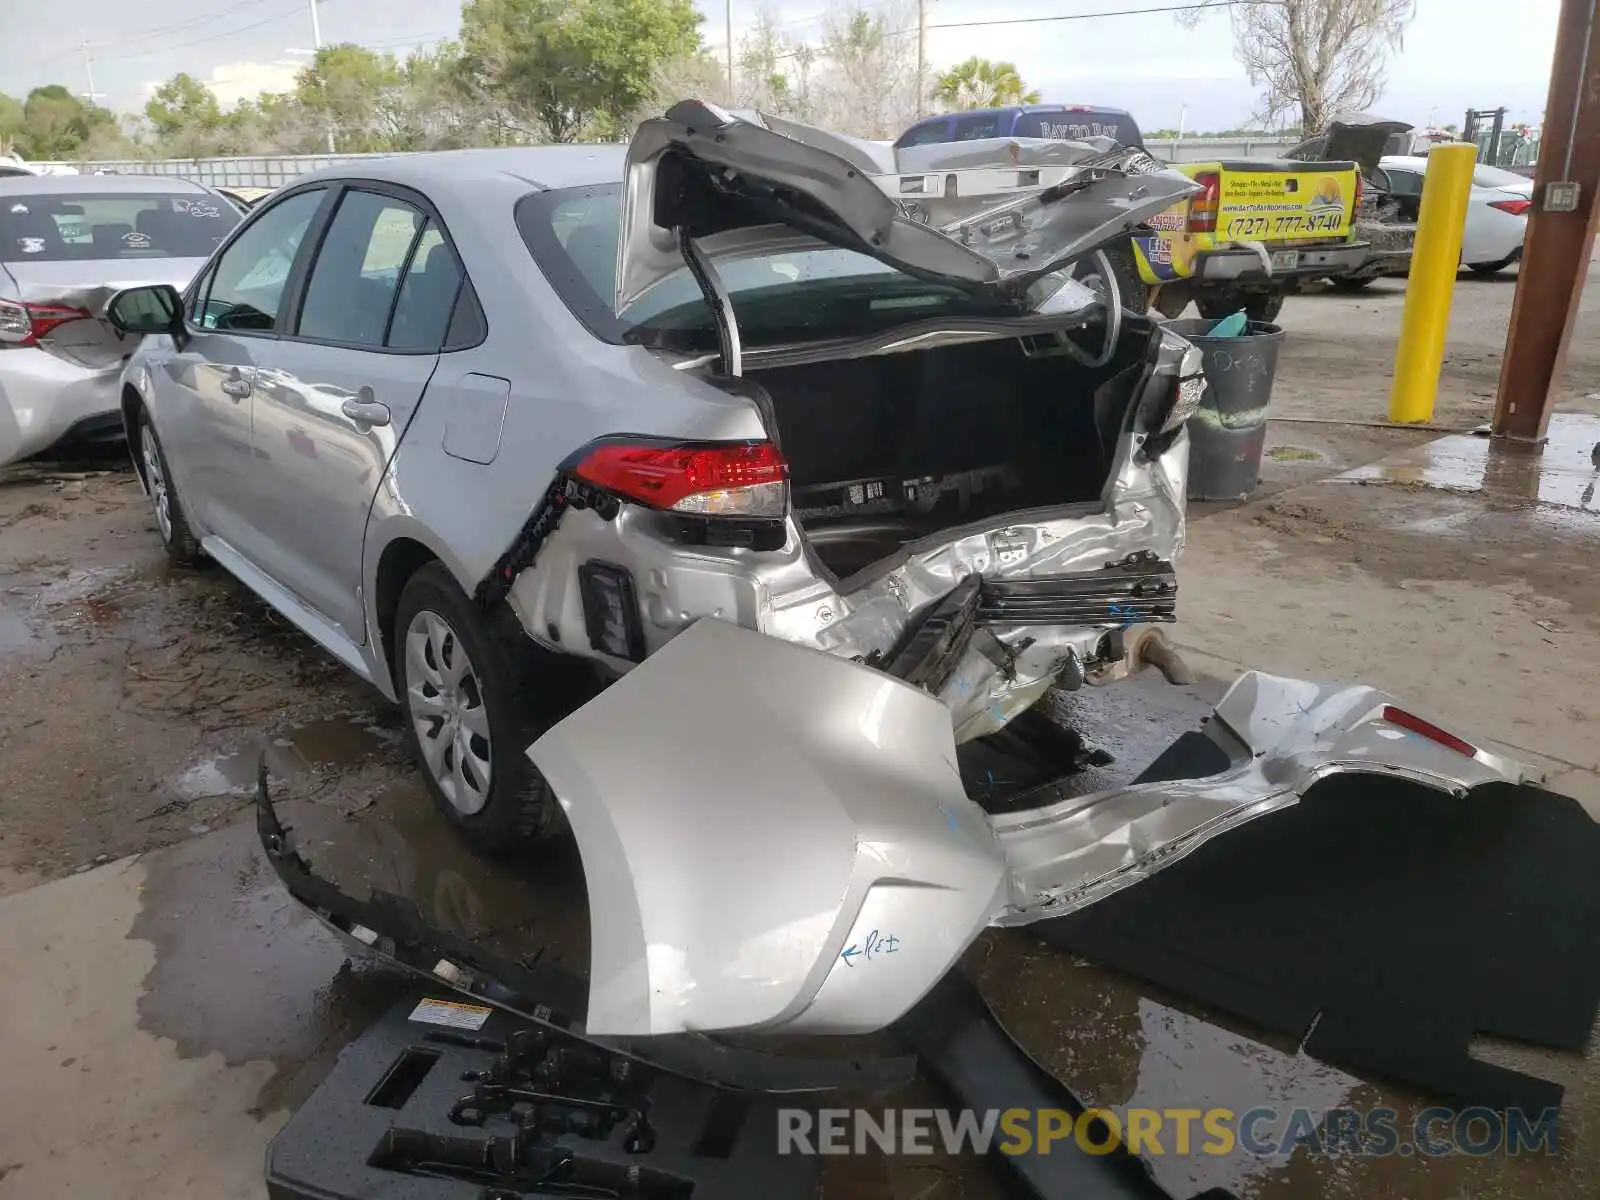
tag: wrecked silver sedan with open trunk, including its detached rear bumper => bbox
[109,102,1522,1035]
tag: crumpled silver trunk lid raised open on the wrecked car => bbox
[616,101,1197,314]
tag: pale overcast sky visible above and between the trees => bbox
[0,0,1558,130]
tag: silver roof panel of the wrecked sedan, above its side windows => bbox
[293,144,627,195]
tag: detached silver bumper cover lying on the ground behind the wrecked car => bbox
[528,619,1531,1035]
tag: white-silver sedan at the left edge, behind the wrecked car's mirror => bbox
[0,174,240,466]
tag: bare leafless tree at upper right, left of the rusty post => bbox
[1179,0,1416,136]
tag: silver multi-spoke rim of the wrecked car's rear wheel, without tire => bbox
[405,608,493,816]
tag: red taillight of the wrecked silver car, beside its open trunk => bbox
[574,442,789,518]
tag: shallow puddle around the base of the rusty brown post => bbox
[1336,413,1600,512]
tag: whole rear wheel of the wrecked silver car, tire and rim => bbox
[394,563,566,856]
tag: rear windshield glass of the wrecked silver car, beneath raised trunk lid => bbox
[517,184,998,350]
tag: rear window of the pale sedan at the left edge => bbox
[0,194,240,262]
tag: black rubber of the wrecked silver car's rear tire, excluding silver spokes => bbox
[390,563,566,858]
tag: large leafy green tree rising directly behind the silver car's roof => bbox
[461,0,701,142]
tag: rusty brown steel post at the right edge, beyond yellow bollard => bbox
[1493,0,1600,442]
